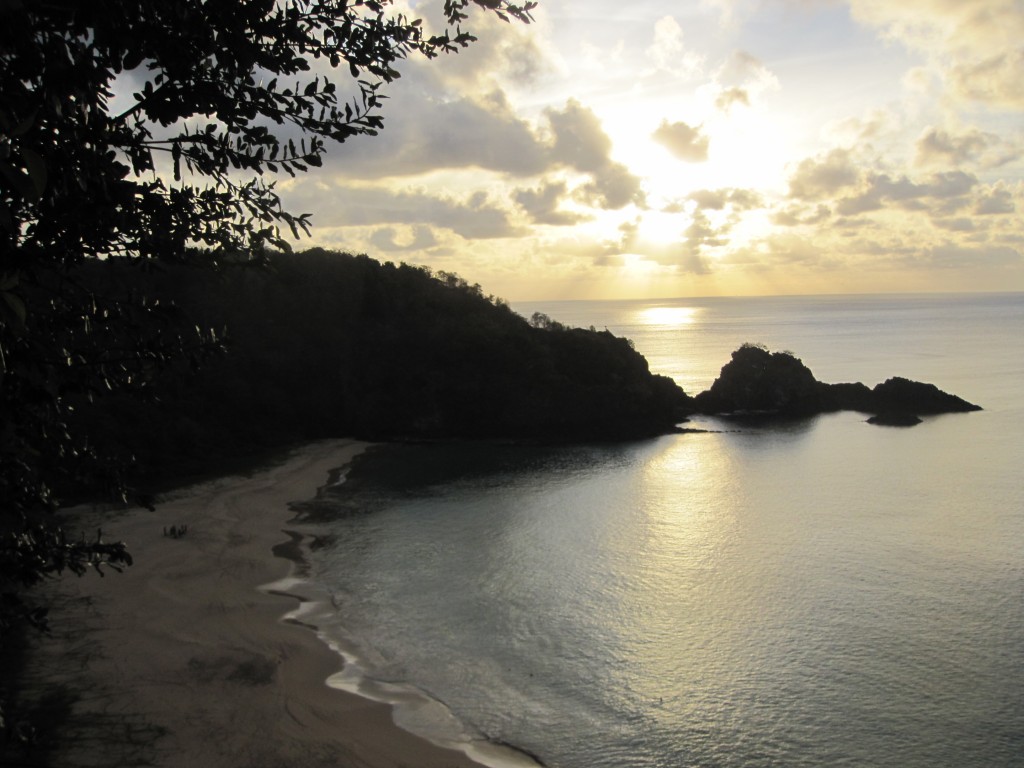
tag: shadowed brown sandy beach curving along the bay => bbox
[17,441,491,768]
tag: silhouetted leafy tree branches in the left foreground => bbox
[0,0,534,745]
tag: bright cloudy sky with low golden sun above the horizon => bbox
[279,0,1024,301]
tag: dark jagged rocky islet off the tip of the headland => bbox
[693,344,981,426]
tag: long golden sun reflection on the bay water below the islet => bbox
[606,435,737,726]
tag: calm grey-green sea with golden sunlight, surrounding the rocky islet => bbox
[296,294,1024,768]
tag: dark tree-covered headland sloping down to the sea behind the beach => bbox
[72,249,690,483]
